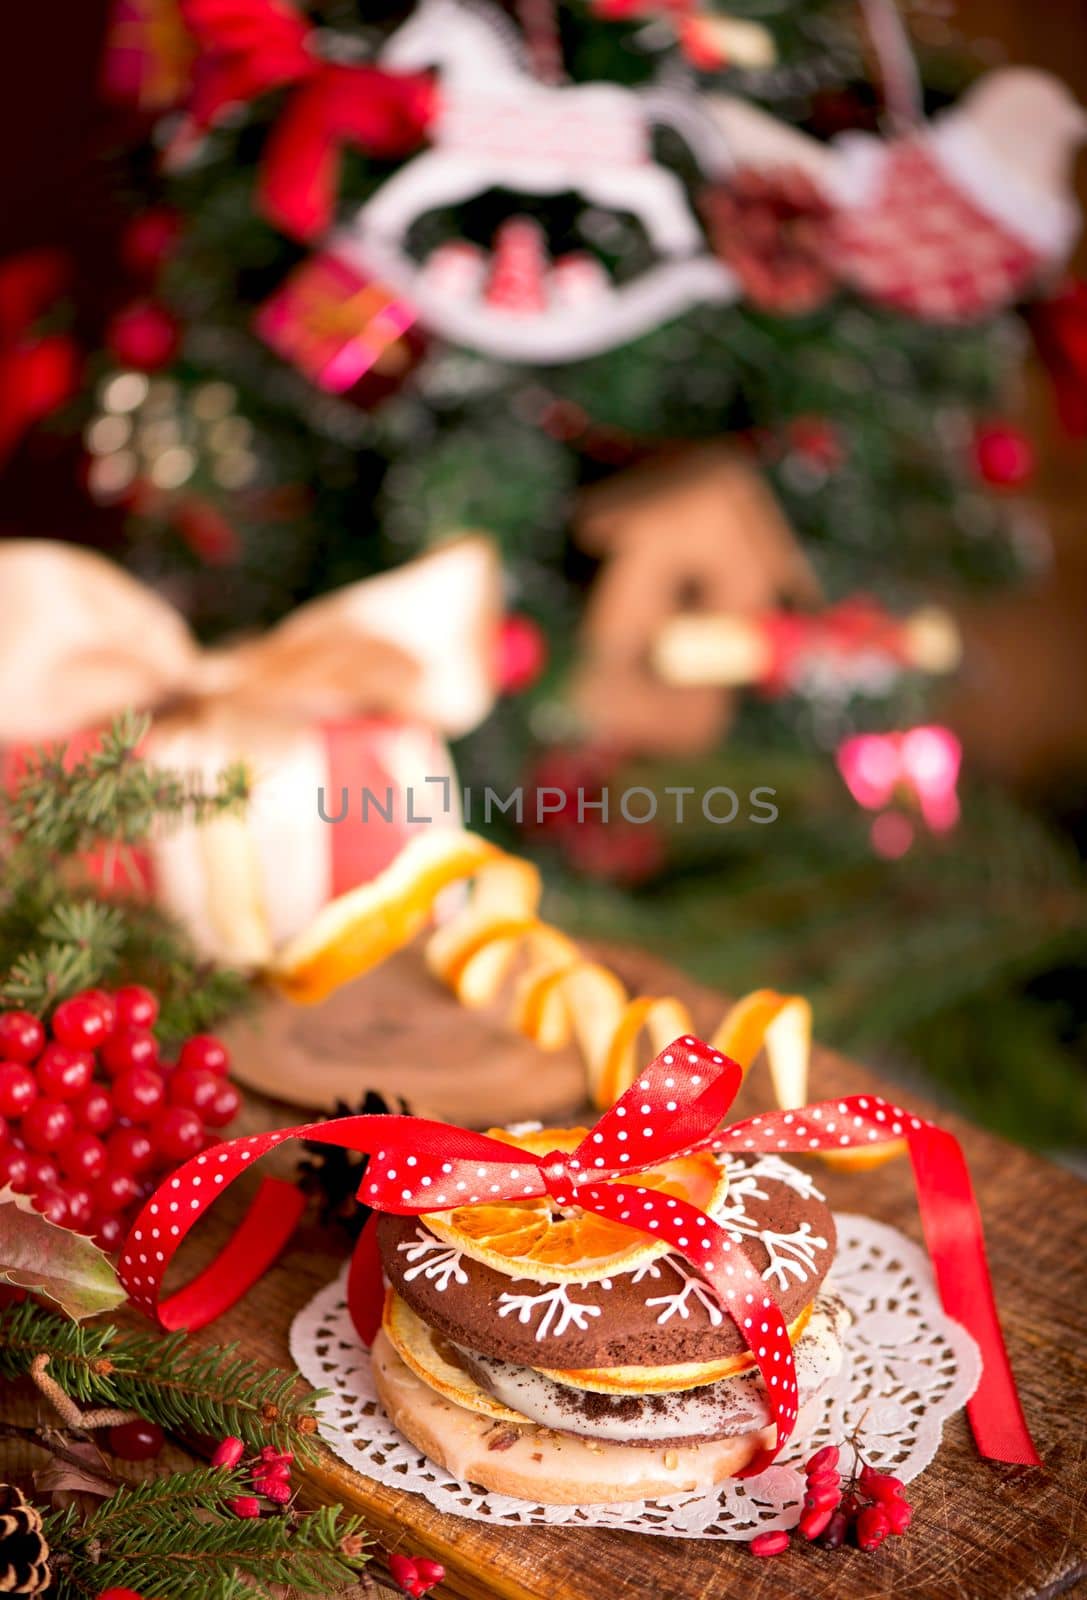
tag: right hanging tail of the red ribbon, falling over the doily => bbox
[909,1128,1042,1467]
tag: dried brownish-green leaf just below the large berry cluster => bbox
[0,1189,128,1322]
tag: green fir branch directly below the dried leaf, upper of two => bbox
[0,1301,319,1456]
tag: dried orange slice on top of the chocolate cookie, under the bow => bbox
[423,1128,728,1283]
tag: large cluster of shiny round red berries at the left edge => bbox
[0,984,240,1251]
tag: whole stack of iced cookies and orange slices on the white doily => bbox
[373,1130,847,1504]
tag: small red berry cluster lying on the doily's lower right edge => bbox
[749,1438,914,1555]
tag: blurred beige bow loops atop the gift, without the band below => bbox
[0,534,499,741]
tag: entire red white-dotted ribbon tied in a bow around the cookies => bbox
[120,1037,1039,1472]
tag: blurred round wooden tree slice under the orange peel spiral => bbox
[219,950,586,1128]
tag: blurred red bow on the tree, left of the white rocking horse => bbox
[183,0,435,238]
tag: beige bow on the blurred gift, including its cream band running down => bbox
[0,534,501,968]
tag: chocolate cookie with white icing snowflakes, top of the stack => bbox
[378,1155,836,1370]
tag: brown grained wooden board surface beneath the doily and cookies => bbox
[17,949,1087,1600]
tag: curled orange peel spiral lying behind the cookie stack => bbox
[266,829,904,1168]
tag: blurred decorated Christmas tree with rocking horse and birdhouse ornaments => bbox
[25,0,1087,1141]
